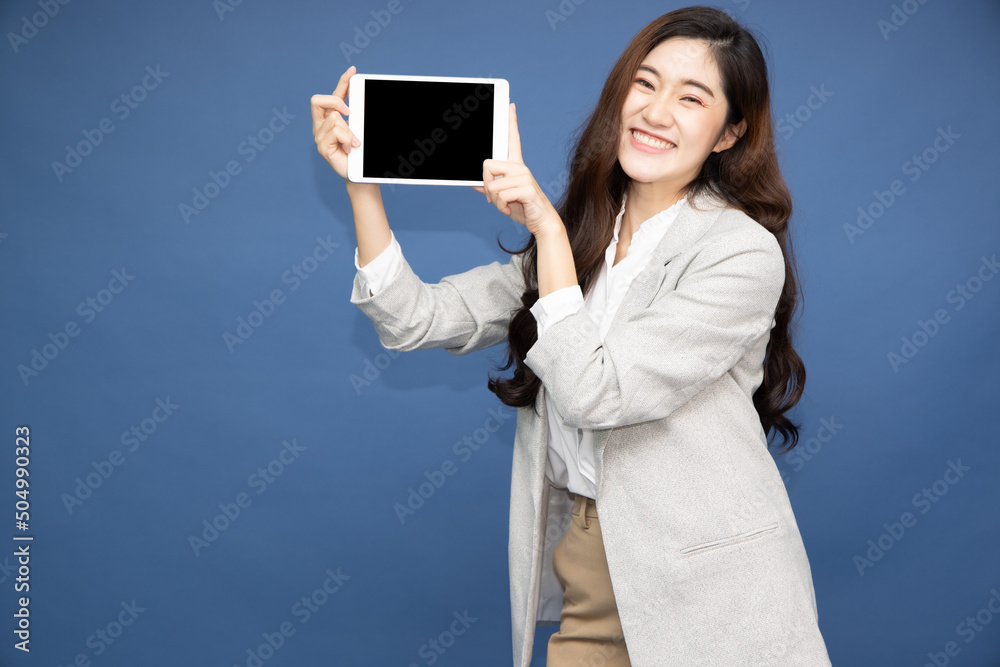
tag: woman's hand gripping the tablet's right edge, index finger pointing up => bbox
[472,104,562,235]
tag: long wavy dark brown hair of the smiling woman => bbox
[488,7,806,453]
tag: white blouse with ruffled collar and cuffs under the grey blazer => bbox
[354,190,687,498]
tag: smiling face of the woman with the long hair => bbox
[618,37,745,199]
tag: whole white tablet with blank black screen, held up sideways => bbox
[347,74,510,185]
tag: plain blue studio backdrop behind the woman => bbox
[0,0,1000,667]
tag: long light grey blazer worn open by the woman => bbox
[351,189,830,667]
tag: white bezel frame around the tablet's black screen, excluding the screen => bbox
[347,74,510,185]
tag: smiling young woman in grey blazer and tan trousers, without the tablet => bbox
[312,7,830,667]
